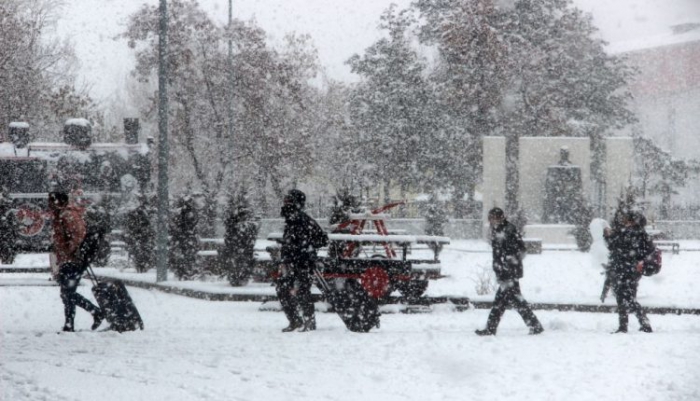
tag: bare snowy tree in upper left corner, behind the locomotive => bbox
[0,0,96,139]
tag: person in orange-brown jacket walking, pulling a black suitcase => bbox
[49,192,104,331]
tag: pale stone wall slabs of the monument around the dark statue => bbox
[478,136,634,245]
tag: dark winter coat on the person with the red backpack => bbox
[605,227,654,278]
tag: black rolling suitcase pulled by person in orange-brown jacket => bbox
[88,267,143,333]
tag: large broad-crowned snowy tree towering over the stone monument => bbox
[415,0,634,214]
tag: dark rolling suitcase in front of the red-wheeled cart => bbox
[314,267,381,333]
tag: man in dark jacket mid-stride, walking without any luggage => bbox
[476,208,544,336]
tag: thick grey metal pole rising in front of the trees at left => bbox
[156,0,169,282]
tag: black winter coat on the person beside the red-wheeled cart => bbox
[280,210,328,268]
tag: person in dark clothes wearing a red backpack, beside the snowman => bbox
[604,211,654,333]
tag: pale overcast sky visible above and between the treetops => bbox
[57,0,700,103]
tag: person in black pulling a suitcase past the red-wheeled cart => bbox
[277,189,328,332]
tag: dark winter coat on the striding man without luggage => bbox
[491,220,525,281]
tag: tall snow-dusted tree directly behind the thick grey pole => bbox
[123,0,317,217]
